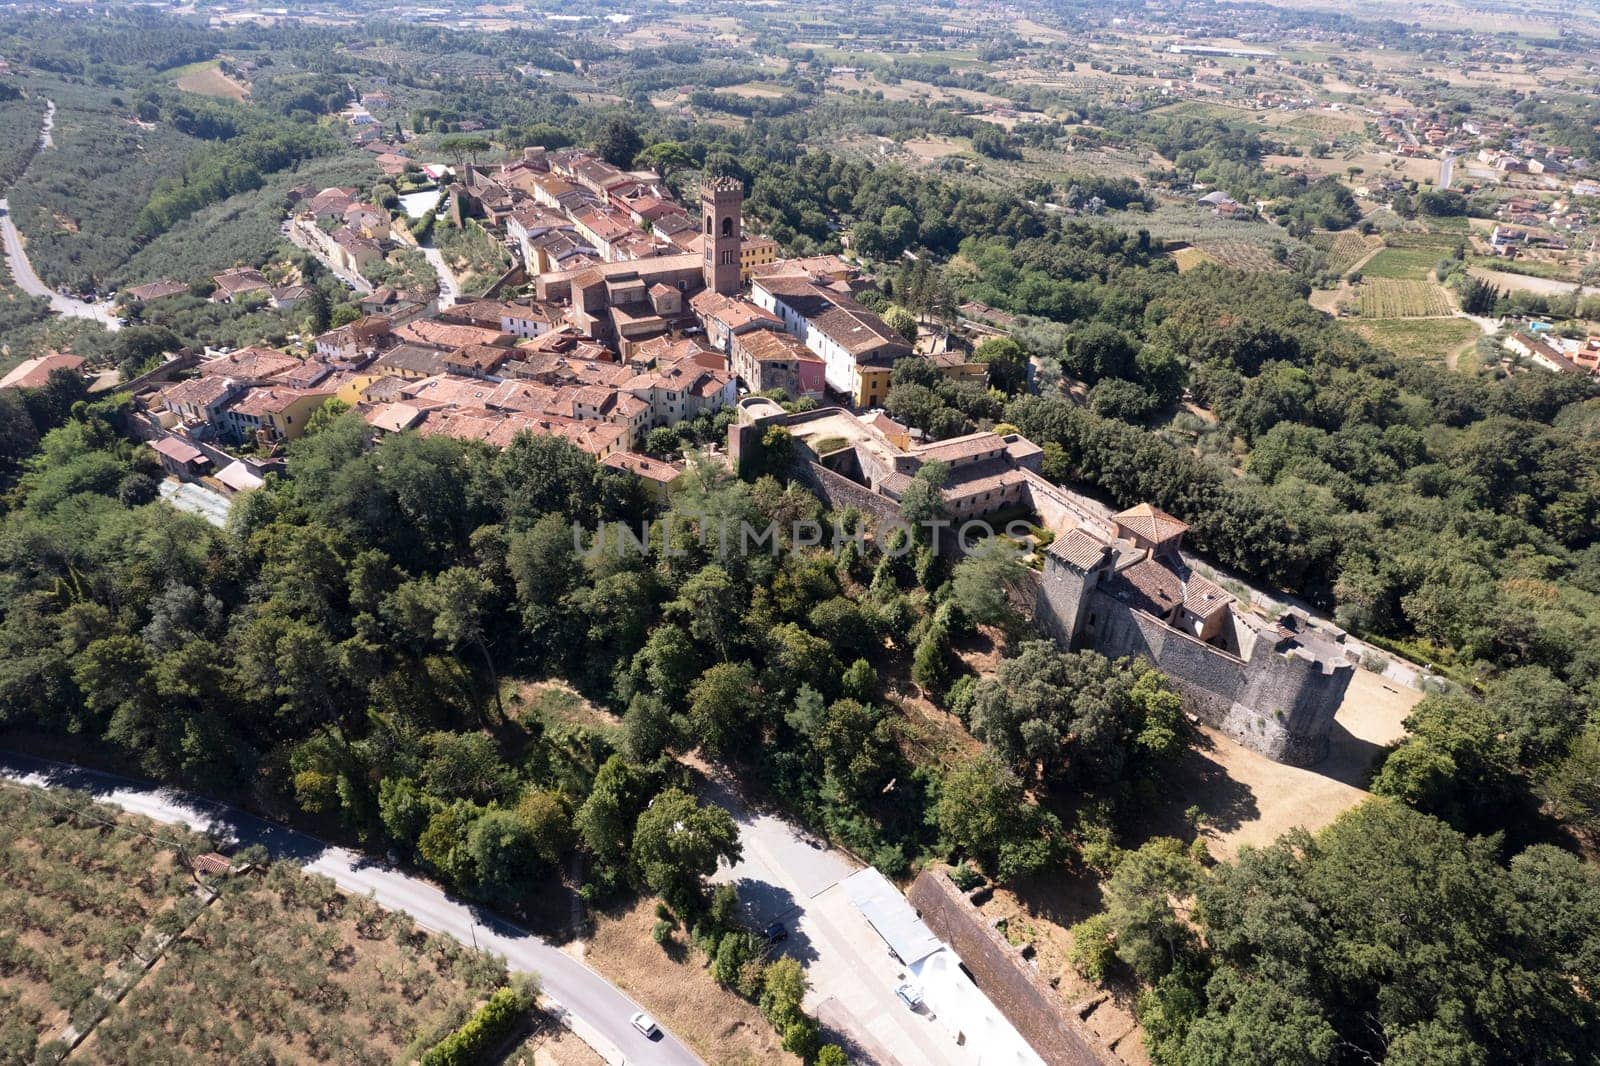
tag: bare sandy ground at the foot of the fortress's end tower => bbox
[1147,669,1422,860]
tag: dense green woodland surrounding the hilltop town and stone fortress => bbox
[0,16,1600,1064]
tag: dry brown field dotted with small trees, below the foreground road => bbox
[0,786,506,1066]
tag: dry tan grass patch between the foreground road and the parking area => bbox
[584,898,800,1066]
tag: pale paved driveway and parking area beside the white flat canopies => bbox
[706,778,978,1066]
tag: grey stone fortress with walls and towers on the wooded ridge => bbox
[728,397,1355,767]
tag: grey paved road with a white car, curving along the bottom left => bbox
[0,751,701,1066]
